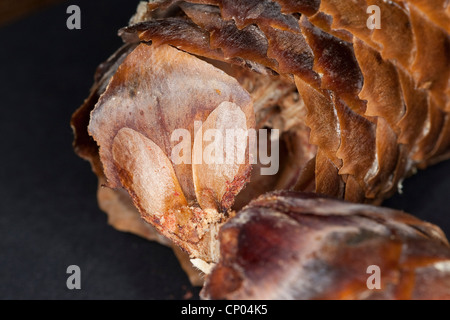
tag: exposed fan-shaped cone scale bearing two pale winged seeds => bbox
[89,44,254,262]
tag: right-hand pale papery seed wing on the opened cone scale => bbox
[192,102,250,211]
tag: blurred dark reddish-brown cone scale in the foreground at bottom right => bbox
[201,192,450,299]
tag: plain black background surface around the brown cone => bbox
[0,0,450,299]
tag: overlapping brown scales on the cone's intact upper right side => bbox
[113,1,449,203]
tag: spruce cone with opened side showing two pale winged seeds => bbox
[71,0,450,292]
